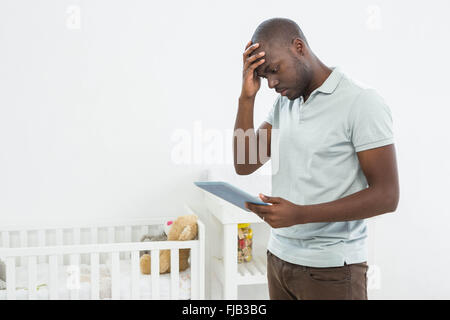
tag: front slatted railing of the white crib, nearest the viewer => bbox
[0,240,201,299]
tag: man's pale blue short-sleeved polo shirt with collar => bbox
[266,68,394,267]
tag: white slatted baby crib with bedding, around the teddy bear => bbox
[0,207,205,300]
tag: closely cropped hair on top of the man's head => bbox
[252,18,308,48]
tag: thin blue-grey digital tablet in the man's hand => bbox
[194,181,269,212]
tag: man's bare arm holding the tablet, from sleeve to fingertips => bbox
[246,144,400,228]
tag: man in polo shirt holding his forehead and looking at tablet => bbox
[234,18,399,299]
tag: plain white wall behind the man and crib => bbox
[0,0,450,299]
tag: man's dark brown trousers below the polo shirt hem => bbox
[267,251,368,300]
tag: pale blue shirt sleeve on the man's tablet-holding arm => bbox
[350,89,394,152]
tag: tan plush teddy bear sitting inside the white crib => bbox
[139,214,198,274]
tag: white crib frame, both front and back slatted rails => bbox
[0,210,205,299]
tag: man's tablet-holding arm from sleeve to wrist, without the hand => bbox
[299,144,400,223]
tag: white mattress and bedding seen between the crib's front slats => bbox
[0,260,191,300]
